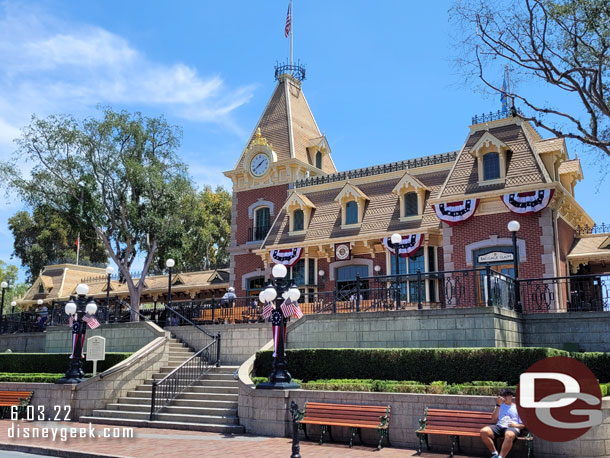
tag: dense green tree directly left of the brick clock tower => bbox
[155,186,231,271]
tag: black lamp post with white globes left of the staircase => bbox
[55,283,97,385]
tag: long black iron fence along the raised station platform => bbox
[0,267,610,333]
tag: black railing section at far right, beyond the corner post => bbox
[519,274,610,313]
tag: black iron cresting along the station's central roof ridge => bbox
[294,151,458,188]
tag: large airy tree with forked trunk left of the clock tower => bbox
[0,108,192,319]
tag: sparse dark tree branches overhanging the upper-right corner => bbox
[452,0,610,156]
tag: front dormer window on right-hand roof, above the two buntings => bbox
[470,132,509,185]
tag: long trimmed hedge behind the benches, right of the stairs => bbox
[254,347,610,385]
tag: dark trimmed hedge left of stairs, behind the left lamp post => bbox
[0,353,132,374]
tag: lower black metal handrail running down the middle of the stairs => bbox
[150,335,220,421]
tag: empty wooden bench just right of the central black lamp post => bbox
[299,402,391,449]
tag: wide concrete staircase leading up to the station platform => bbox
[79,339,244,434]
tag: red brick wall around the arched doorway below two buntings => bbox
[445,212,544,278]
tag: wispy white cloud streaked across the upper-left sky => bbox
[0,2,254,157]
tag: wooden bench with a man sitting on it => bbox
[416,409,534,458]
